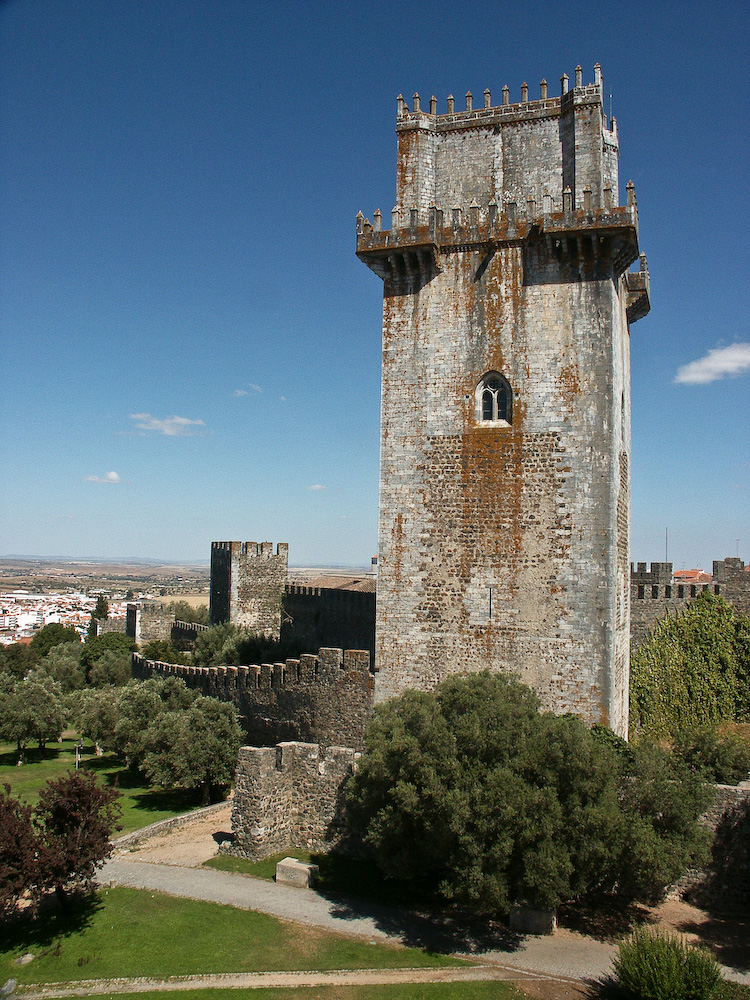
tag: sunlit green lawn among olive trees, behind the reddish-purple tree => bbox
[0,740,206,833]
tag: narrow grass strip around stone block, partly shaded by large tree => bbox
[204,847,435,909]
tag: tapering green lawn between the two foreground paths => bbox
[0,888,461,983]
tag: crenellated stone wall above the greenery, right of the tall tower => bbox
[630,558,750,646]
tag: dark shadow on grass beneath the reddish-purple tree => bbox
[0,892,103,956]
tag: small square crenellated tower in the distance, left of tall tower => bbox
[209,542,289,639]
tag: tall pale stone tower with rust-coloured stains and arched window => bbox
[357,65,649,735]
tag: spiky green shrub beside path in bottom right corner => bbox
[614,927,721,1000]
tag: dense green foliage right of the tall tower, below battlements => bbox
[630,591,750,739]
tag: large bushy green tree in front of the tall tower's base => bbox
[346,673,705,912]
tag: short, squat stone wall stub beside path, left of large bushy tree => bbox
[229,742,359,861]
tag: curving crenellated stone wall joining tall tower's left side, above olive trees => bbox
[132,649,374,749]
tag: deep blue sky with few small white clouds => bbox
[0,0,750,568]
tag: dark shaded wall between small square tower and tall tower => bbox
[281,584,375,661]
